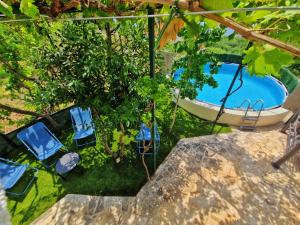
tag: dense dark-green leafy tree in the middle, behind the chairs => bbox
[35,20,171,161]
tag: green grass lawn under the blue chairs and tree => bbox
[8,109,230,225]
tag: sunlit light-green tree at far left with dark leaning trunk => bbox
[0,21,60,132]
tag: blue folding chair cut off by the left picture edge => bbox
[0,158,38,196]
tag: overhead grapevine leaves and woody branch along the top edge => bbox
[1,0,300,56]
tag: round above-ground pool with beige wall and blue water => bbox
[174,63,290,126]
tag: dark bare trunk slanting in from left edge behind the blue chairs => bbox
[0,103,61,133]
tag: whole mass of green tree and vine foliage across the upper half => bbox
[0,0,300,154]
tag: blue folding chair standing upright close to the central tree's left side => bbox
[70,107,97,147]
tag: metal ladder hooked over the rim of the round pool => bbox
[238,99,264,131]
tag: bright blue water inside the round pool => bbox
[174,64,286,109]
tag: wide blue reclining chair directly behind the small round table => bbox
[17,122,64,168]
